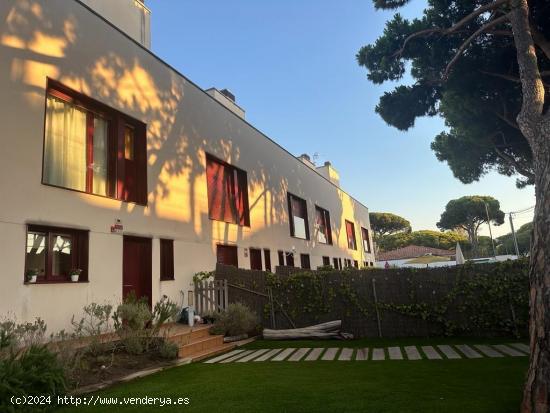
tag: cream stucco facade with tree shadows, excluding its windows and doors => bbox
[0,0,374,331]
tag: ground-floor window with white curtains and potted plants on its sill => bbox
[25,225,88,283]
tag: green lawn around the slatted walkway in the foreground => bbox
[56,339,528,413]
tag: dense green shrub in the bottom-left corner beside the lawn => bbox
[0,344,67,413]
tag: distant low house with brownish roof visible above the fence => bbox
[376,245,456,268]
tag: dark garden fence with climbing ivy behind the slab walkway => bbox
[215,260,529,337]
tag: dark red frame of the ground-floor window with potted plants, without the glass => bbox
[24,224,89,284]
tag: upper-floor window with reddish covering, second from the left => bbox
[206,154,250,226]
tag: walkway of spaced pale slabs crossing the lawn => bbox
[204,343,529,364]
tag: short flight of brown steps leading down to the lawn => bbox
[163,323,236,361]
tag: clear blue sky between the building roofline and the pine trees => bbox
[147,0,535,235]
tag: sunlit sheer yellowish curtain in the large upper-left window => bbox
[44,96,86,191]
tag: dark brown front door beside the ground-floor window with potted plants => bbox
[122,235,152,306]
